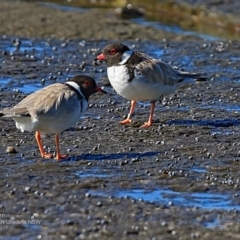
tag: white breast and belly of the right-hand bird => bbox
[108,66,176,101]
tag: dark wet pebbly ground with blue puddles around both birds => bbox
[0,0,240,240]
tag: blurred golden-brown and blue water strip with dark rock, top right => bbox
[24,0,240,39]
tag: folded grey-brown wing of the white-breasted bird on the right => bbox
[136,59,202,86]
